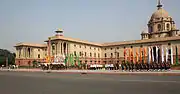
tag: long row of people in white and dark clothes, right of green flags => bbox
[88,62,171,71]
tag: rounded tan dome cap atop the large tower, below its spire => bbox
[151,8,170,19]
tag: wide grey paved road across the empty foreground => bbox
[0,71,180,94]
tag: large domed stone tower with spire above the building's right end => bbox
[148,0,179,38]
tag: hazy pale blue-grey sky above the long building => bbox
[0,0,180,50]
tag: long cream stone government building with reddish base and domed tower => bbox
[15,1,180,66]
